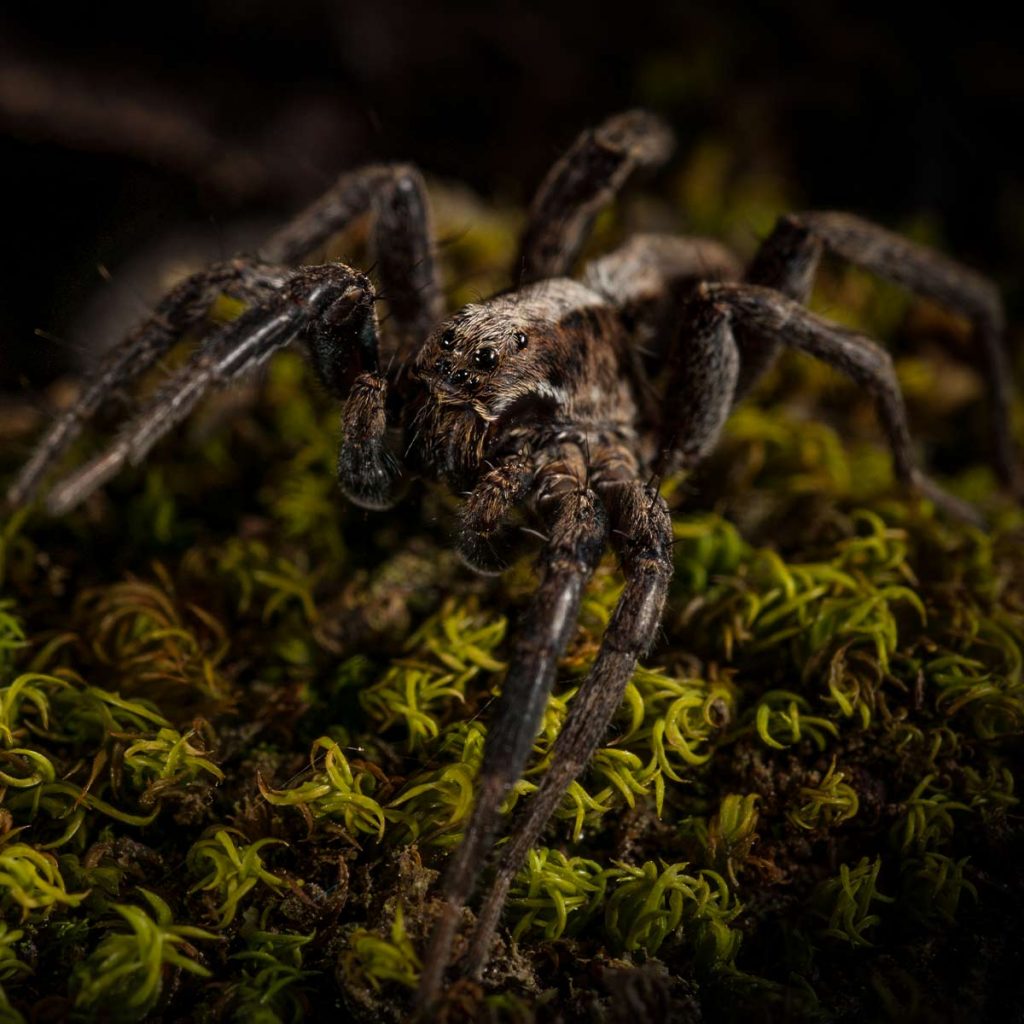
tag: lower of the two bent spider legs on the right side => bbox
[694,284,984,525]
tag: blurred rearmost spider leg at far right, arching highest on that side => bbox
[737,212,1024,496]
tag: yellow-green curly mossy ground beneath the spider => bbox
[0,163,1024,1021]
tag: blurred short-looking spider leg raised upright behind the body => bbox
[514,111,675,288]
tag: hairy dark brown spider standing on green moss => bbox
[8,111,1021,1009]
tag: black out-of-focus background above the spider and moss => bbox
[0,0,1024,392]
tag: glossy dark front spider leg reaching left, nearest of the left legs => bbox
[47,263,378,515]
